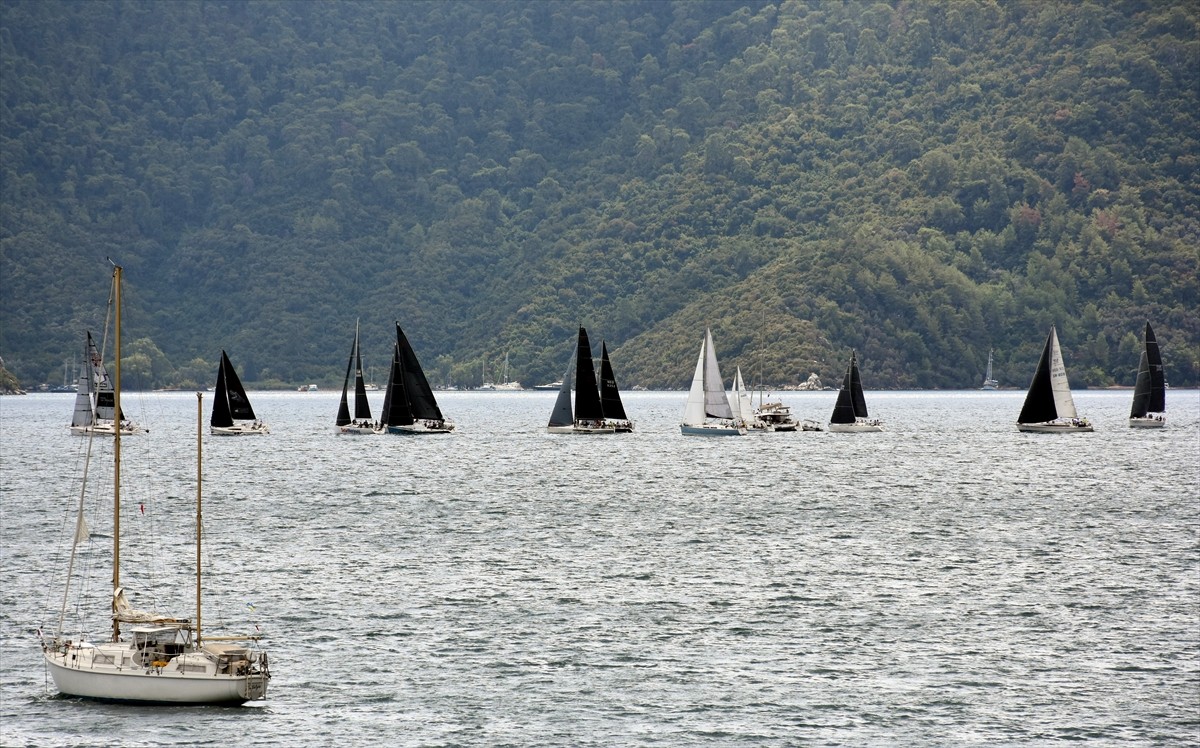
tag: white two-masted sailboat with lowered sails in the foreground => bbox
[42,265,271,705]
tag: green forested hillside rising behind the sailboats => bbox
[0,0,1200,388]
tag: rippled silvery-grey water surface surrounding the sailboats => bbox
[0,390,1200,746]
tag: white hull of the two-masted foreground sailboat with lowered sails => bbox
[46,647,269,705]
